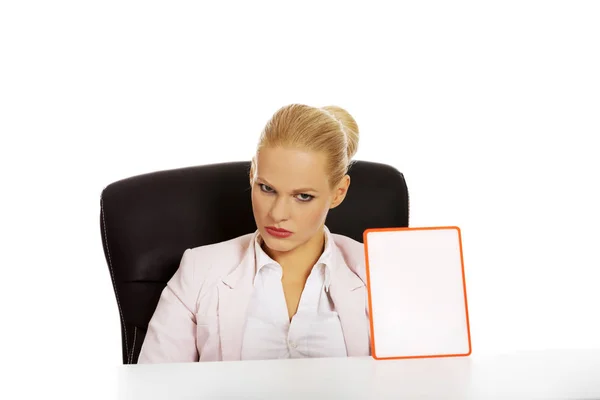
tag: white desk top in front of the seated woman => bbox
[119,350,600,400]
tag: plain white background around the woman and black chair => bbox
[0,0,600,393]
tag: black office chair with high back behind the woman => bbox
[100,161,409,364]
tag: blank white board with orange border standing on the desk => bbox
[365,228,470,358]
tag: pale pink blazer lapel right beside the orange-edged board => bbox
[329,249,370,357]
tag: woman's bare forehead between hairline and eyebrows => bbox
[256,147,328,190]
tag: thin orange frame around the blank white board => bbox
[363,226,472,360]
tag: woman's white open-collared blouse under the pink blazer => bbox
[242,228,347,360]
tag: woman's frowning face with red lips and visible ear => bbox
[252,147,349,252]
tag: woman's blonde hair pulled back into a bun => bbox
[250,104,358,187]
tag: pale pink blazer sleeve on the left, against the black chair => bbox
[138,249,199,364]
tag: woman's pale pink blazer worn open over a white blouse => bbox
[138,232,371,364]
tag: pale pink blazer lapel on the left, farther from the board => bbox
[218,240,255,361]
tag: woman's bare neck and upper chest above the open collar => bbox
[264,228,325,284]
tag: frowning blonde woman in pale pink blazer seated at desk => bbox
[138,104,370,363]
